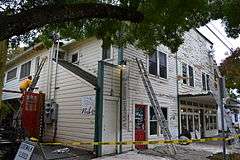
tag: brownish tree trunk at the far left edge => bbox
[0,40,8,108]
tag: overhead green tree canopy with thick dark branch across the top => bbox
[0,0,240,108]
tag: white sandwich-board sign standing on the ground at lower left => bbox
[14,142,34,160]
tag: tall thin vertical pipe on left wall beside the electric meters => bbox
[53,39,59,141]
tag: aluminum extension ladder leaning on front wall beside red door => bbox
[136,58,176,154]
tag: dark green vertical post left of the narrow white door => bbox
[94,61,104,157]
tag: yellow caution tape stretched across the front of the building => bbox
[30,134,240,146]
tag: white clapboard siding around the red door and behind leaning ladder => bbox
[123,42,178,150]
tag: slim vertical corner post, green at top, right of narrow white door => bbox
[118,47,123,153]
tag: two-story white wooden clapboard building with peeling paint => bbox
[3,30,219,155]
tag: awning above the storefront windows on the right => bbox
[179,92,217,106]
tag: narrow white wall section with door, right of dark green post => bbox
[102,64,120,155]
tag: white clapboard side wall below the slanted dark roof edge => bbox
[46,62,96,150]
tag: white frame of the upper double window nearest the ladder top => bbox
[147,49,168,80]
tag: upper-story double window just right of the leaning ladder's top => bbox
[149,51,167,79]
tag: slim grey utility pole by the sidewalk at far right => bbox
[219,77,226,160]
